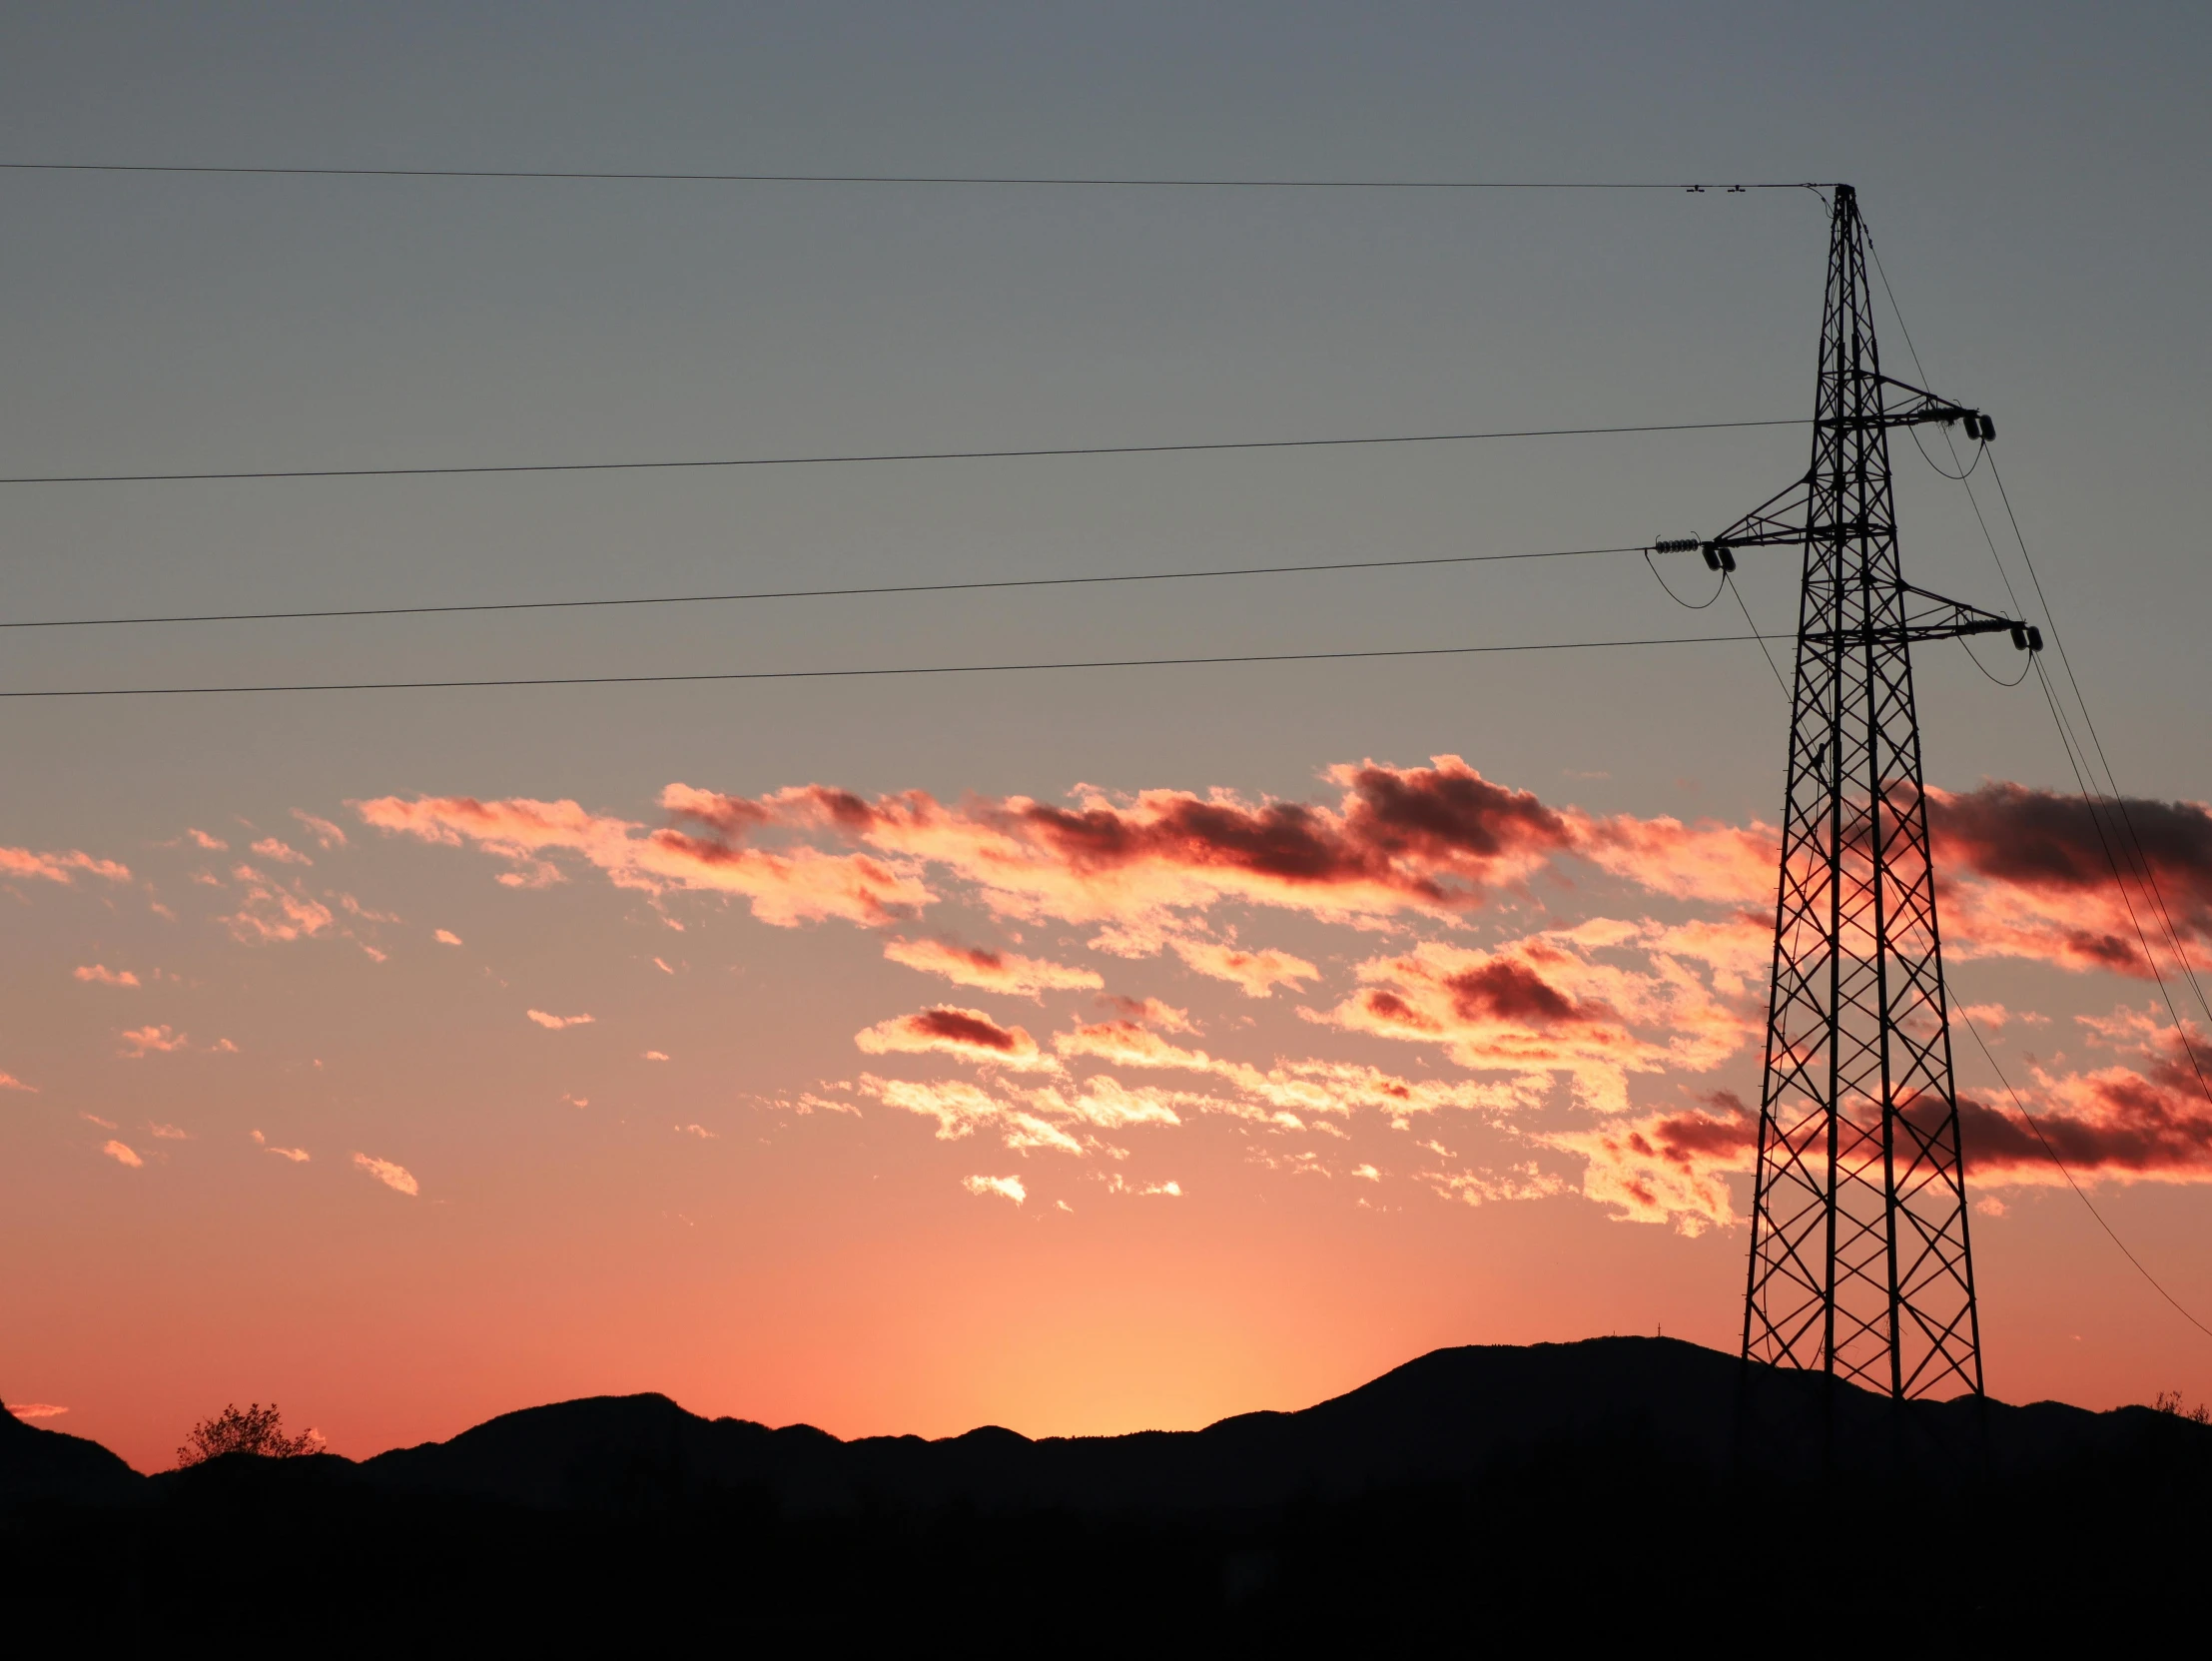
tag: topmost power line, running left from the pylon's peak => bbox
[0,162,1821,195]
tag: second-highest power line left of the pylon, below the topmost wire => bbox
[0,415,1808,484]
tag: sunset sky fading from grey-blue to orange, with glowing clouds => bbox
[0,4,2212,1468]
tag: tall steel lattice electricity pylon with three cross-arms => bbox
[1677,186,2041,1397]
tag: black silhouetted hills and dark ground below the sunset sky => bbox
[0,1338,2212,1654]
